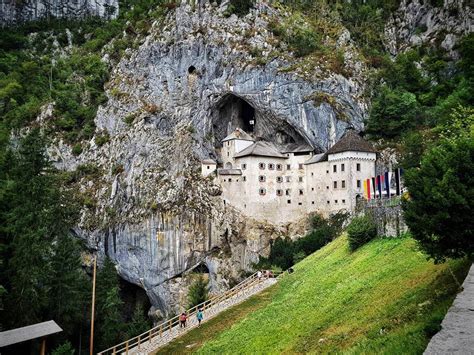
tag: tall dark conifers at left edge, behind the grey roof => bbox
[0,129,88,352]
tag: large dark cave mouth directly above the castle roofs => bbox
[211,94,308,148]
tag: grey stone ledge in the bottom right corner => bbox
[424,264,474,355]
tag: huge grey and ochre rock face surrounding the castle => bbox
[43,1,367,313]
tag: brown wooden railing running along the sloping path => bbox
[98,272,281,355]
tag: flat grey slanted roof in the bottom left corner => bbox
[0,320,63,348]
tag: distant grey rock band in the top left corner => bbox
[0,0,119,26]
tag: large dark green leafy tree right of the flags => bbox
[403,135,474,261]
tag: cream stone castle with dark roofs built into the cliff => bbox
[201,128,377,224]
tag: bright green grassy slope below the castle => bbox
[160,237,469,354]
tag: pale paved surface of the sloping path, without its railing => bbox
[128,278,277,355]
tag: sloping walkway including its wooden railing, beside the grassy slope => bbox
[98,273,278,355]
